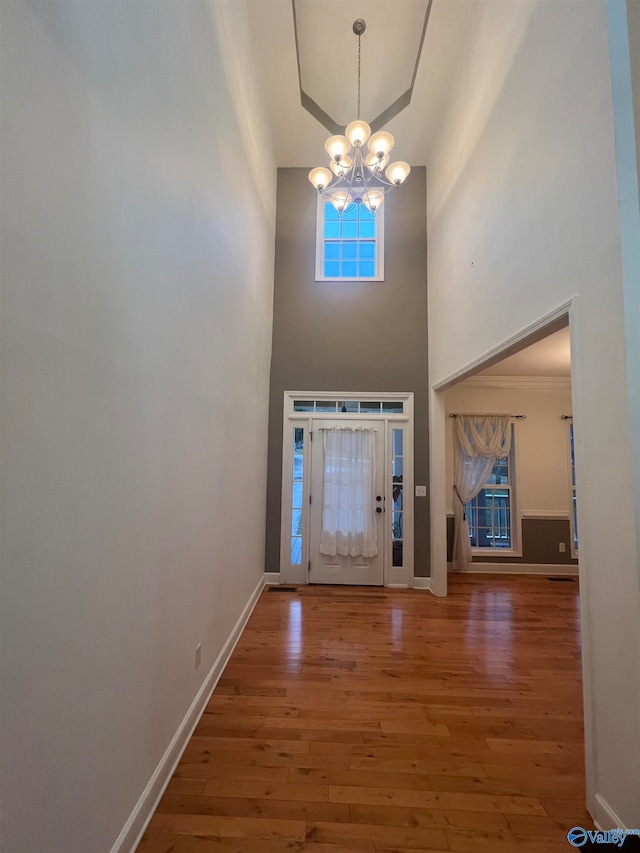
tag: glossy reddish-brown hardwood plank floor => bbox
[138,575,593,853]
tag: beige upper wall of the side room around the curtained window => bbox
[445,380,571,518]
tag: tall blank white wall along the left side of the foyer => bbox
[0,0,276,853]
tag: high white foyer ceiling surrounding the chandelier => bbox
[248,0,477,167]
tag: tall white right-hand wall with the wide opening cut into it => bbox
[427,0,640,826]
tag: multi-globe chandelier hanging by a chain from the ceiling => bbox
[309,18,411,216]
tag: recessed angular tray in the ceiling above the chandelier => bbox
[291,0,432,133]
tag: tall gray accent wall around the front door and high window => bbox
[266,167,429,576]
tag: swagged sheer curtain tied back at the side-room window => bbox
[453,415,511,569]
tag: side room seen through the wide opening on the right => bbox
[444,326,578,576]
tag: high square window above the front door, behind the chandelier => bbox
[316,196,384,281]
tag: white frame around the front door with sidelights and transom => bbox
[280,391,415,587]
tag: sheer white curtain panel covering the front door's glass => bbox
[320,427,378,557]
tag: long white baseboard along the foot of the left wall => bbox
[111,575,265,853]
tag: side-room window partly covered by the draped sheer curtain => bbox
[465,426,515,551]
